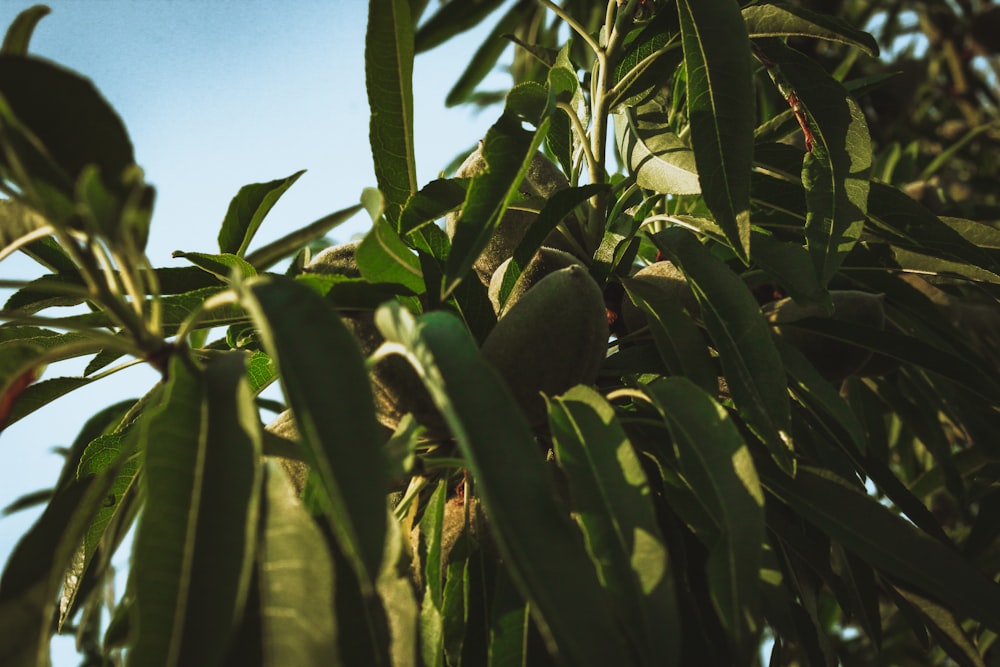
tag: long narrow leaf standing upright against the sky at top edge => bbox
[365,0,417,226]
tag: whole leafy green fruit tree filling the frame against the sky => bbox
[0,0,1000,666]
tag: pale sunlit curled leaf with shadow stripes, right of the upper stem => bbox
[614,105,701,195]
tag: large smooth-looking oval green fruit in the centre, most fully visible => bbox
[482,265,608,427]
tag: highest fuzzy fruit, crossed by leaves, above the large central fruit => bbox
[446,142,571,285]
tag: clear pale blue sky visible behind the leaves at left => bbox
[0,0,509,667]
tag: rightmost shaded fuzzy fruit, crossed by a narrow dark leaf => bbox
[764,290,885,384]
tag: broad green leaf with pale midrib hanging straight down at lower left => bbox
[129,352,261,665]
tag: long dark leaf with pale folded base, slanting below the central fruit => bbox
[375,303,625,666]
